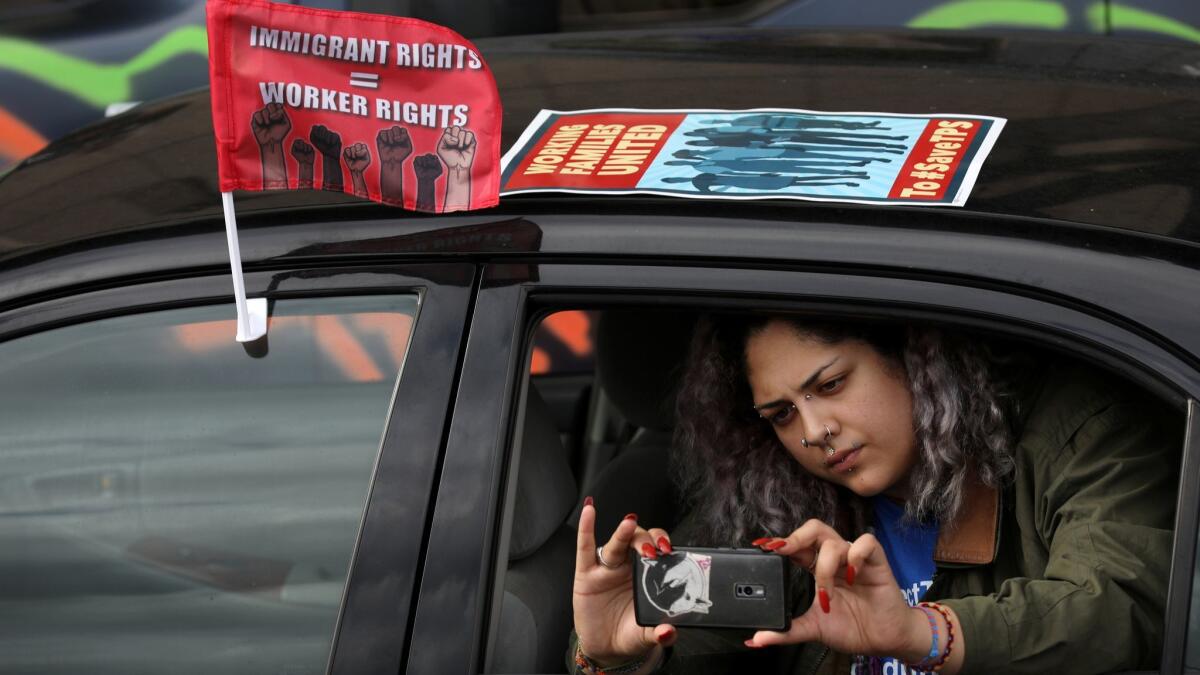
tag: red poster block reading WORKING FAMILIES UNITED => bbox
[505,113,686,190]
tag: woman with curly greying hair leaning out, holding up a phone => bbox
[574,317,1182,674]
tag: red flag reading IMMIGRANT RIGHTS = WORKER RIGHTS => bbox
[208,0,500,211]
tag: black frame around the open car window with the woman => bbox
[408,261,1200,675]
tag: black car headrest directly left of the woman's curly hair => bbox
[595,310,696,431]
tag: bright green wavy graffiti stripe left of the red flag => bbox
[0,25,209,108]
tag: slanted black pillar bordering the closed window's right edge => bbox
[329,264,474,675]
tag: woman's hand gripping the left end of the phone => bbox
[572,497,676,667]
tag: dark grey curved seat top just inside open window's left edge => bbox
[509,384,578,561]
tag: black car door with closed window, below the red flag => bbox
[0,264,474,674]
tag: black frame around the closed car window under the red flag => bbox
[0,262,476,675]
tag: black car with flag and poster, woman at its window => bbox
[0,30,1200,675]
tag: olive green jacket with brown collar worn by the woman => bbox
[592,366,1183,674]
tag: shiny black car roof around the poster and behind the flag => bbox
[0,29,1200,265]
